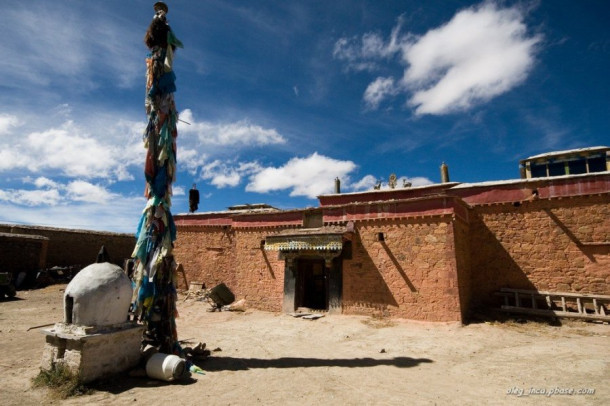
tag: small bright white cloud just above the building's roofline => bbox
[246,152,356,199]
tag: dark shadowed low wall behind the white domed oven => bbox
[0,225,135,267]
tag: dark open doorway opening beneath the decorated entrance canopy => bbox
[295,259,328,310]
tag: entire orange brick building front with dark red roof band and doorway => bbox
[174,167,610,322]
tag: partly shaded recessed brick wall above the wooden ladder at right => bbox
[470,195,610,304]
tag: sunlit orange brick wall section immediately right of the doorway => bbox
[343,216,461,321]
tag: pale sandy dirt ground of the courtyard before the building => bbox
[0,285,610,405]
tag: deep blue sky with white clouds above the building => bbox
[0,0,610,232]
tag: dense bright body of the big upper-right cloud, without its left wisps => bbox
[403,3,540,114]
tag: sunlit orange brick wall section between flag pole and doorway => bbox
[174,226,284,311]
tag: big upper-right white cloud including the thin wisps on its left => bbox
[334,2,542,115]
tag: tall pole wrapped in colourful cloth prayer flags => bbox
[131,9,182,355]
